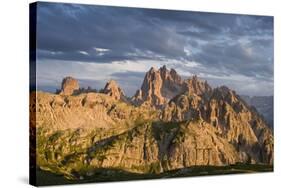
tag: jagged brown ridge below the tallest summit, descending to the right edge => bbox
[162,86,273,163]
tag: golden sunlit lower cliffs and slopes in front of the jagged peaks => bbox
[33,92,249,178]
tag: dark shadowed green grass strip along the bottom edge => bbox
[37,164,273,185]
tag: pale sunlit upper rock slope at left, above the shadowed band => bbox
[31,92,158,130]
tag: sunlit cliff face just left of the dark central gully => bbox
[89,124,160,173]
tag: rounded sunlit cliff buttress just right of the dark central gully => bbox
[168,120,241,169]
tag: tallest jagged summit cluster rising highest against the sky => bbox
[132,66,211,108]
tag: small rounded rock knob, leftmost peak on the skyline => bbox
[60,76,79,95]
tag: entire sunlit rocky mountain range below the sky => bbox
[30,66,274,182]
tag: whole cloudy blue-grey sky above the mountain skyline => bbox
[36,2,274,96]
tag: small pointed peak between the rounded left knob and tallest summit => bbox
[103,80,125,100]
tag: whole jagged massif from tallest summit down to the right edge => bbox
[133,66,273,163]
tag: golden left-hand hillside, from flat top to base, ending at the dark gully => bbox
[33,92,158,178]
